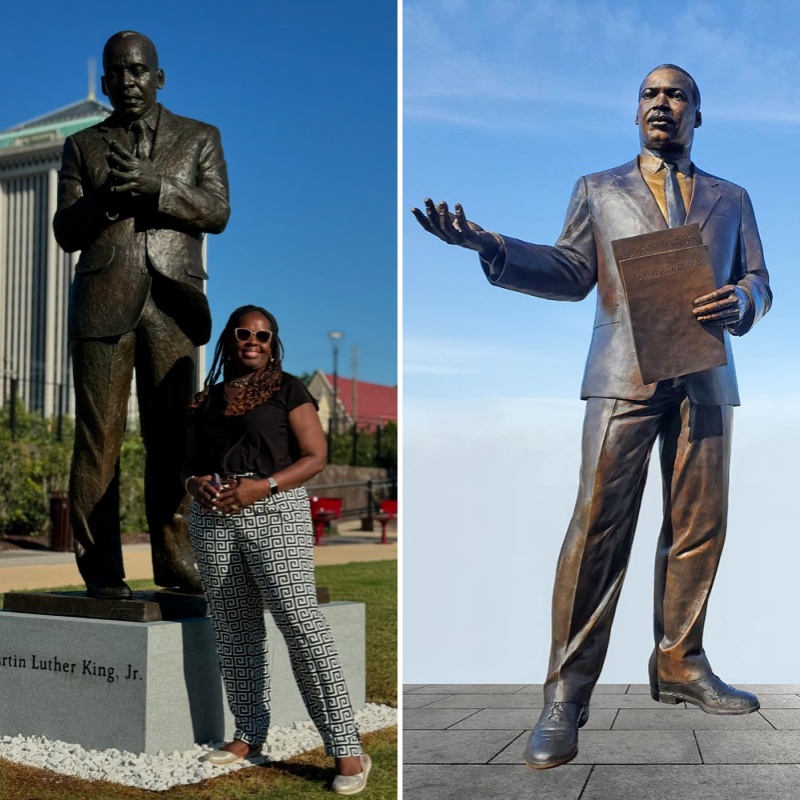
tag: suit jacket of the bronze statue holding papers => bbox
[482,159,772,405]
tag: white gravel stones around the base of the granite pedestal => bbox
[0,703,397,792]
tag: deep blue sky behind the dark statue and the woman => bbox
[0,0,397,384]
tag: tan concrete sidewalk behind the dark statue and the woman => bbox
[0,520,397,593]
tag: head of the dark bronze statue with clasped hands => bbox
[101,31,164,118]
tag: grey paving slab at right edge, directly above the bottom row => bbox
[695,731,800,764]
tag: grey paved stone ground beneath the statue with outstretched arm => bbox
[403,684,800,800]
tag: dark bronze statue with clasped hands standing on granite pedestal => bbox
[53,31,230,598]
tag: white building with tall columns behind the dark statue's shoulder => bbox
[0,98,111,416]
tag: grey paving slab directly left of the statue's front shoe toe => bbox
[403,730,522,764]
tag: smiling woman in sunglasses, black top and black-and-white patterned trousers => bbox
[183,306,371,794]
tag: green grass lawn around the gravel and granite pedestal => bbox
[0,561,398,800]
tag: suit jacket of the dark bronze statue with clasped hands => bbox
[53,106,230,345]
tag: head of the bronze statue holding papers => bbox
[636,68,701,151]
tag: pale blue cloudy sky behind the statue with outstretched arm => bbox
[403,0,800,683]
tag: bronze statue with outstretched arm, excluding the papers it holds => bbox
[414,64,772,769]
